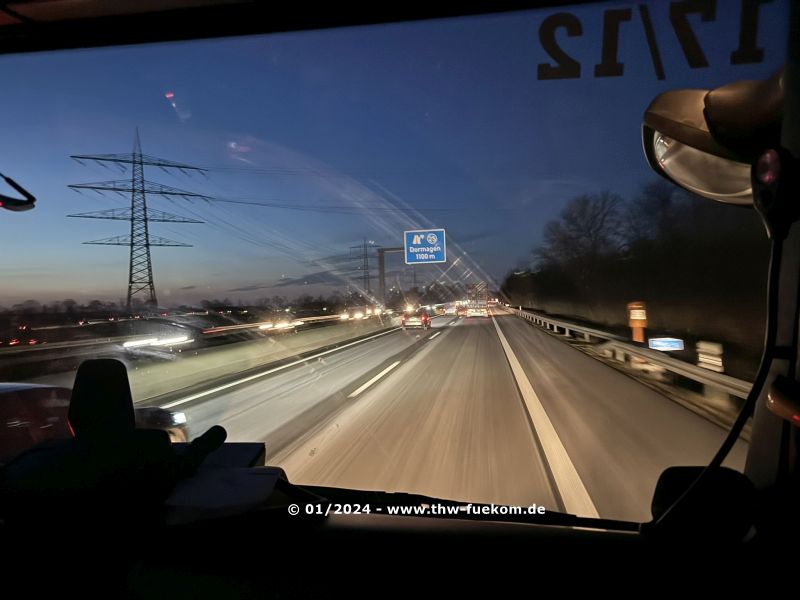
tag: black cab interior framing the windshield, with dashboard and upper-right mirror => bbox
[0,0,800,598]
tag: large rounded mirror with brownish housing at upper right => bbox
[642,73,783,206]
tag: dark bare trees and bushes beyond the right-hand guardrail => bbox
[502,180,769,376]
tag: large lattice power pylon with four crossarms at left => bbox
[67,129,212,311]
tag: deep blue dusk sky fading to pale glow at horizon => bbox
[0,1,788,306]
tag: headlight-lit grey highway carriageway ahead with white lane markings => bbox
[159,313,747,521]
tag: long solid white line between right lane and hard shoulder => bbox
[492,317,600,517]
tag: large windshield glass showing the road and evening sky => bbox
[0,1,788,521]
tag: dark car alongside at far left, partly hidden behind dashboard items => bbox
[0,382,189,464]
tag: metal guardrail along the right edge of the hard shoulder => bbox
[505,307,752,398]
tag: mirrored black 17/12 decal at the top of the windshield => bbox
[537,0,772,79]
